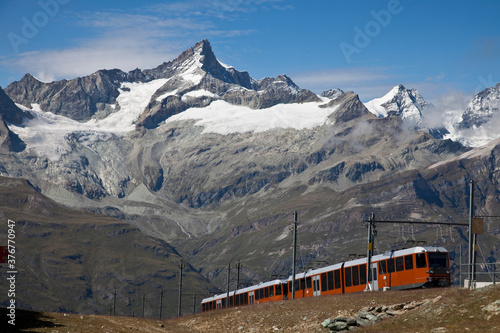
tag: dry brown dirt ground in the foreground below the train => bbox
[0,285,500,333]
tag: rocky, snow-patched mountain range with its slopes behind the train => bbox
[0,40,500,316]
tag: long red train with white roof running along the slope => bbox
[201,246,451,312]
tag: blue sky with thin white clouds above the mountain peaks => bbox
[0,0,500,101]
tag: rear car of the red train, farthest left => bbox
[201,280,288,312]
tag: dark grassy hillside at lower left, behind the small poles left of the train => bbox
[0,177,210,317]
